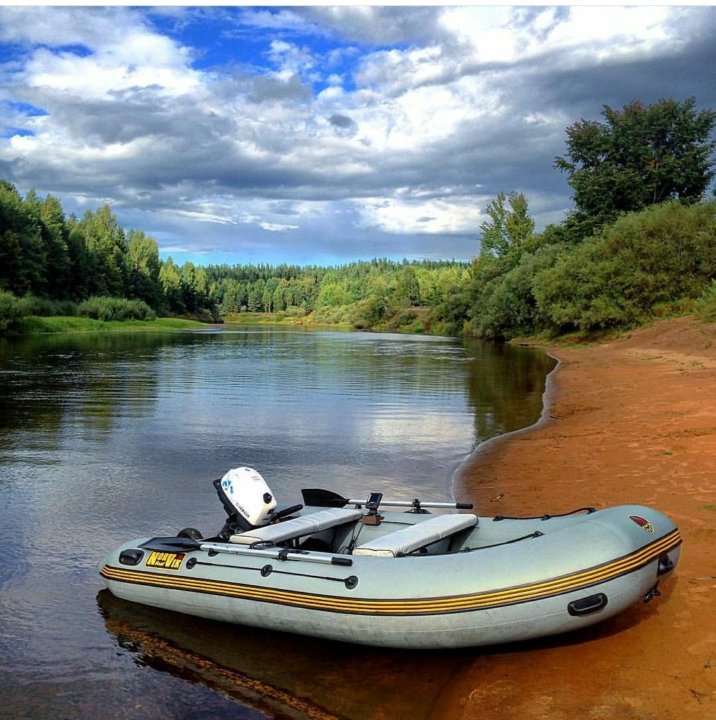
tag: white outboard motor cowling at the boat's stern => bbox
[215,467,276,530]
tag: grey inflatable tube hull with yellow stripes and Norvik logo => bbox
[100,506,681,648]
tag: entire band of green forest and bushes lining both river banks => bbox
[0,98,716,340]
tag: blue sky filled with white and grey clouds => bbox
[0,4,716,265]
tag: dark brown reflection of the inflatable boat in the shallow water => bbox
[97,591,471,720]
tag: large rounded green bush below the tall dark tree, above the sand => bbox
[534,202,716,331]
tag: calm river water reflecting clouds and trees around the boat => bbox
[0,327,553,719]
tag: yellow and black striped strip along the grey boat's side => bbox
[101,530,681,616]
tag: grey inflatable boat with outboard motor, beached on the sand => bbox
[99,468,681,648]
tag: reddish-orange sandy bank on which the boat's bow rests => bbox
[442,318,716,720]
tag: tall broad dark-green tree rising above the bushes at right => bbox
[554,98,716,228]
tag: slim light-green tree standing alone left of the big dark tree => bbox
[480,192,535,257]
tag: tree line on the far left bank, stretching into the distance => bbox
[0,180,468,330]
